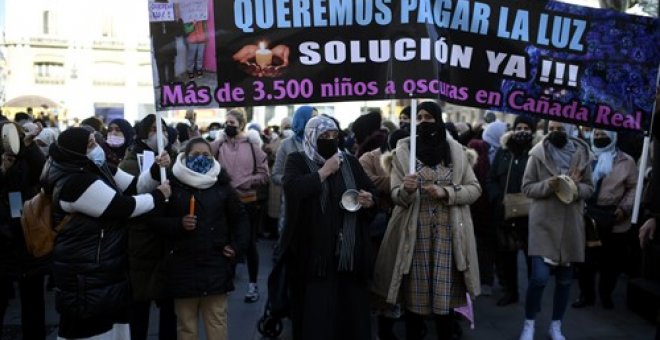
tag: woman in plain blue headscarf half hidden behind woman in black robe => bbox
[270,105,318,239]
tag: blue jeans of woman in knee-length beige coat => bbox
[525,256,573,321]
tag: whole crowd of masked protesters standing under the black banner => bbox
[0,101,660,340]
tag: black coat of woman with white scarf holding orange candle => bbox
[149,171,249,298]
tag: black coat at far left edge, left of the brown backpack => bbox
[0,143,49,277]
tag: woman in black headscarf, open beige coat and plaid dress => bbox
[373,102,481,339]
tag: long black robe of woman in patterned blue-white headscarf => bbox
[282,152,376,339]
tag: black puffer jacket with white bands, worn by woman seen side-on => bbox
[44,161,164,319]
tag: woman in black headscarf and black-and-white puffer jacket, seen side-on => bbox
[42,128,170,339]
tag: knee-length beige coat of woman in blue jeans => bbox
[522,137,594,263]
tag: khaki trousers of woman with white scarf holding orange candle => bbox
[174,294,227,340]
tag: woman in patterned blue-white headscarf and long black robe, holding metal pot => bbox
[281,116,375,340]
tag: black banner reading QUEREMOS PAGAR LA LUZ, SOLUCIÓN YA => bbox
[150,0,660,130]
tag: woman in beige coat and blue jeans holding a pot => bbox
[520,121,594,340]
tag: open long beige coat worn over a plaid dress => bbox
[372,138,481,304]
